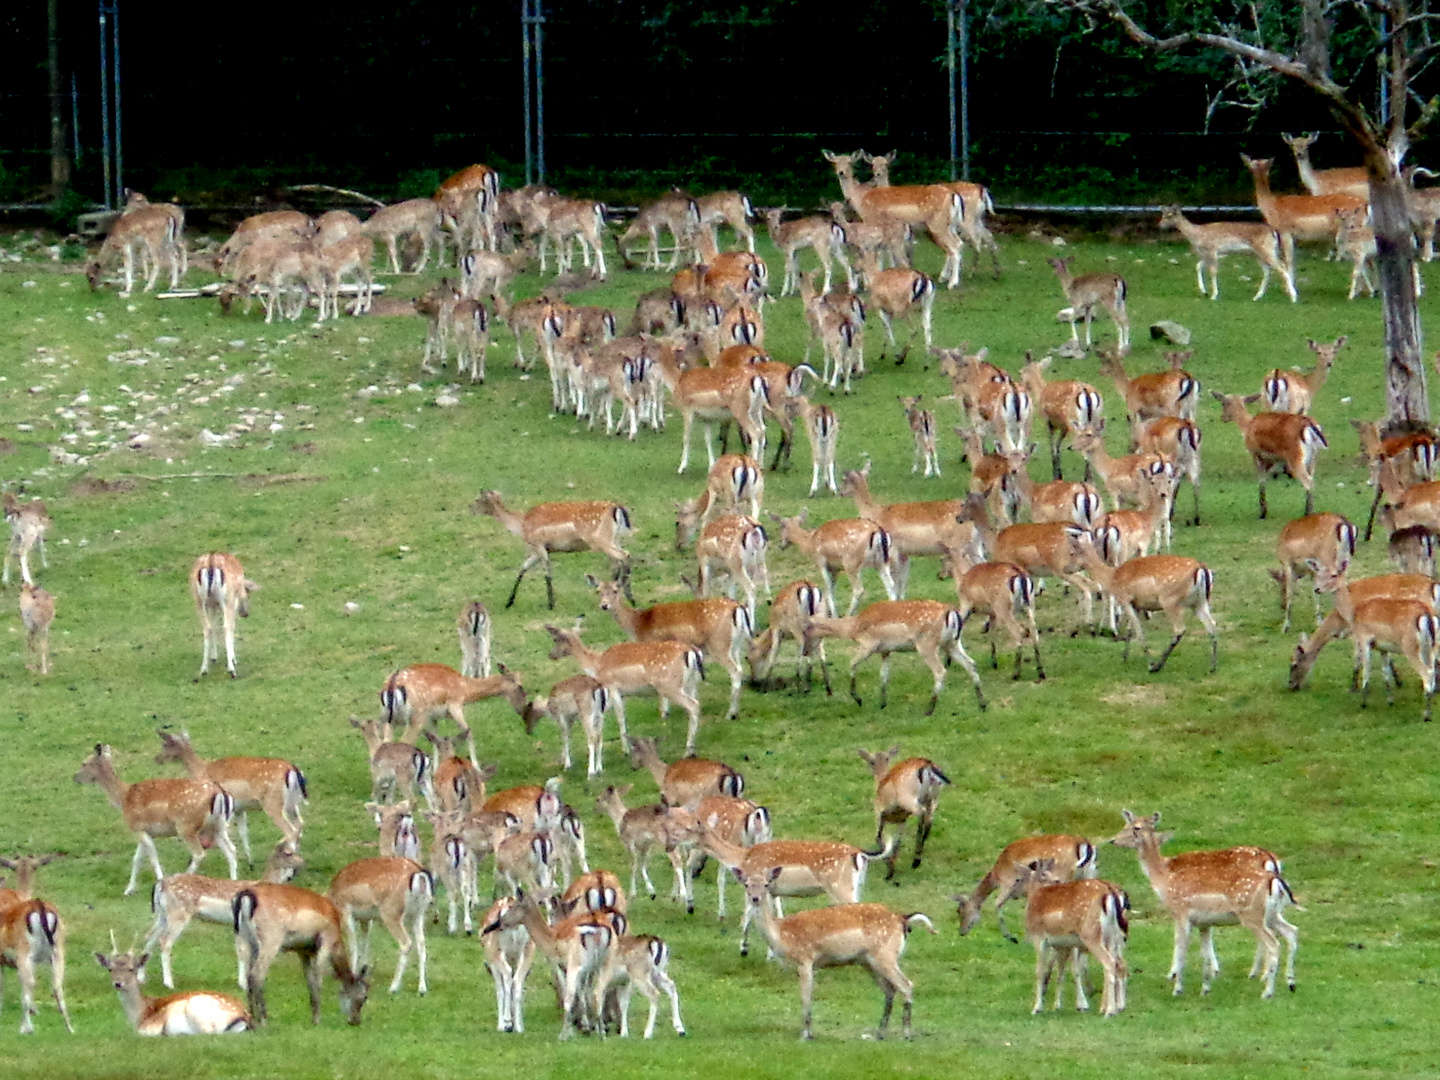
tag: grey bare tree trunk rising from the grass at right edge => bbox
[1367,153,1430,433]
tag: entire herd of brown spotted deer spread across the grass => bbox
[16,131,1440,1038]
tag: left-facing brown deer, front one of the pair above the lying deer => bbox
[73,743,236,896]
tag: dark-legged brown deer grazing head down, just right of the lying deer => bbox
[230,883,370,1027]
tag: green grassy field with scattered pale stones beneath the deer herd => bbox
[0,221,1440,1077]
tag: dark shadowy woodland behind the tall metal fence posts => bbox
[0,0,1426,202]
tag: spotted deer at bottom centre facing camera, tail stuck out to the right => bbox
[740,867,936,1041]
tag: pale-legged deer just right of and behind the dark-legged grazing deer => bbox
[328,857,435,995]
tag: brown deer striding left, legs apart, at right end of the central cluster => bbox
[1080,537,1220,675]
